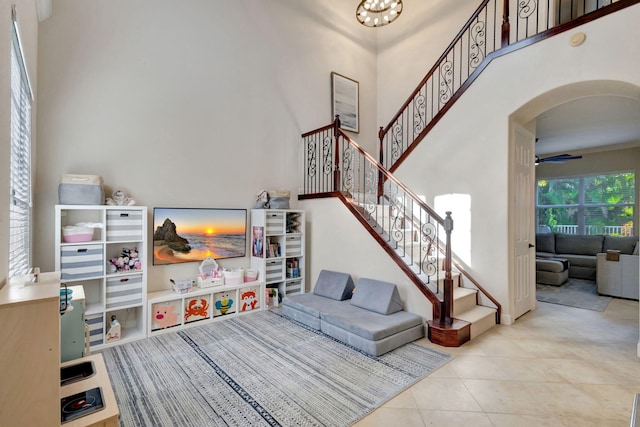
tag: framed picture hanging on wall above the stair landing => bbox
[331,72,360,133]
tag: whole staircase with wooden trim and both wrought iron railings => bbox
[298,0,640,346]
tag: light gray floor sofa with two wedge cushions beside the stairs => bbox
[282,270,424,356]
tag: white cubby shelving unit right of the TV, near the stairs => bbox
[249,209,305,299]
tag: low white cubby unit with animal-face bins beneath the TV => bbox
[147,281,265,336]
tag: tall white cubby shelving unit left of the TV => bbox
[55,205,147,350]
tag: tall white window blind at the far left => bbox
[8,9,32,278]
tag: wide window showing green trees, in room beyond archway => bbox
[536,172,636,236]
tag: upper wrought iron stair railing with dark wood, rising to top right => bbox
[378,0,640,172]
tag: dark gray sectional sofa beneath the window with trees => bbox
[536,233,638,280]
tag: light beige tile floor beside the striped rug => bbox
[355,298,640,427]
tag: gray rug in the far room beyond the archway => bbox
[536,278,611,311]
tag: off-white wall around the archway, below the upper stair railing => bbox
[378,5,640,323]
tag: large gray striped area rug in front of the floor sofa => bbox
[101,311,451,427]
